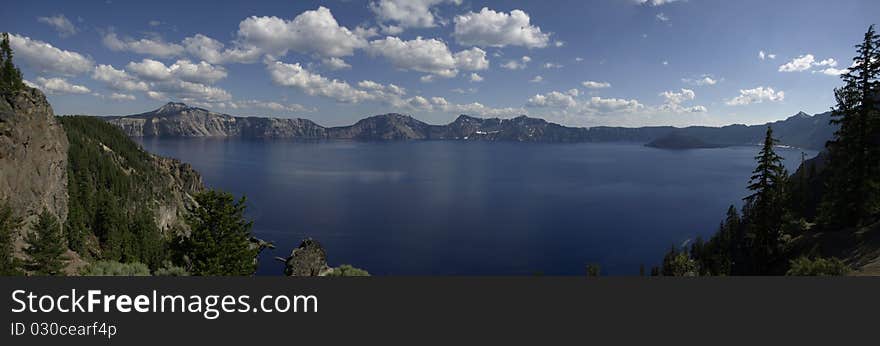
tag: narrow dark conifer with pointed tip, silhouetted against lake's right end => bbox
[744,126,788,274]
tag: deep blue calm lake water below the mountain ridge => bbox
[141,138,815,275]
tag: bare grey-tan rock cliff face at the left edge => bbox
[0,88,68,238]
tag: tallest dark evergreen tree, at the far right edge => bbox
[820,25,880,227]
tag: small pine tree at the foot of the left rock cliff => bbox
[25,210,66,275]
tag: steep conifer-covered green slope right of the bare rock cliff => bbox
[59,116,170,269]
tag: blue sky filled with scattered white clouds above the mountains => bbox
[0,0,880,126]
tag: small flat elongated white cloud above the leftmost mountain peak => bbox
[126,59,227,83]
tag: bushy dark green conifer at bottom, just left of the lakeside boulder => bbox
[180,190,260,275]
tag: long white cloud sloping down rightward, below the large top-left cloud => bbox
[266,61,374,103]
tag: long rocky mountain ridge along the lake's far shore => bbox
[103,102,835,150]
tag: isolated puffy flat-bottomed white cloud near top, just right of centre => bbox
[452,7,550,48]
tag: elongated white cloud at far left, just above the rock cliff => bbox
[9,34,95,75]
